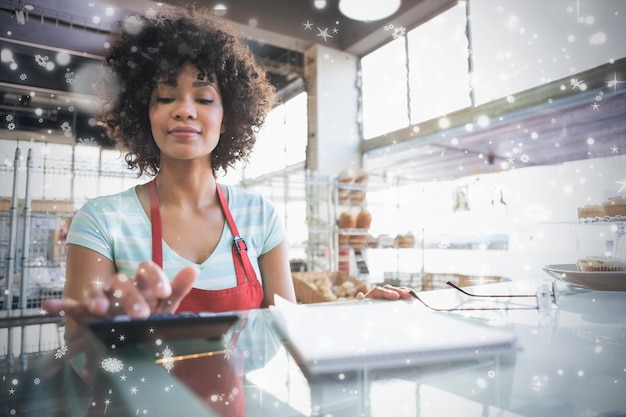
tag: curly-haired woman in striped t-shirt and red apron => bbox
[44,9,409,323]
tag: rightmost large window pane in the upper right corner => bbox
[470,0,626,104]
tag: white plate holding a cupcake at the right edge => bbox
[543,264,626,291]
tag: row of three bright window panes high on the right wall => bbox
[361,0,626,139]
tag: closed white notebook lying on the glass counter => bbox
[270,297,517,375]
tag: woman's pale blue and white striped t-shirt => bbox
[67,186,286,290]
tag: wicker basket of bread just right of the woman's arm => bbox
[291,272,369,304]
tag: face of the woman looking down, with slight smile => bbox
[148,64,224,165]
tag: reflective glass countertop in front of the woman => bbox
[0,280,626,417]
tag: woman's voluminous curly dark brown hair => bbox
[95,7,275,176]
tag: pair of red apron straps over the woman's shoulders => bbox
[150,177,257,285]
